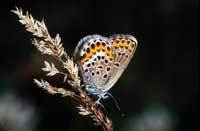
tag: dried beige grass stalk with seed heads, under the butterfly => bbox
[12,7,113,131]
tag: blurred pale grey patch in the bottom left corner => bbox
[0,92,37,131]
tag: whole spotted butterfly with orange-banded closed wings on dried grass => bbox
[74,34,137,101]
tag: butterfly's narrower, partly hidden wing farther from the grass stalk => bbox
[103,34,137,92]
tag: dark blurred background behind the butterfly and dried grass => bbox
[0,0,199,131]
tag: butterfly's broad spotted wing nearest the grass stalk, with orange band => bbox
[74,35,114,91]
